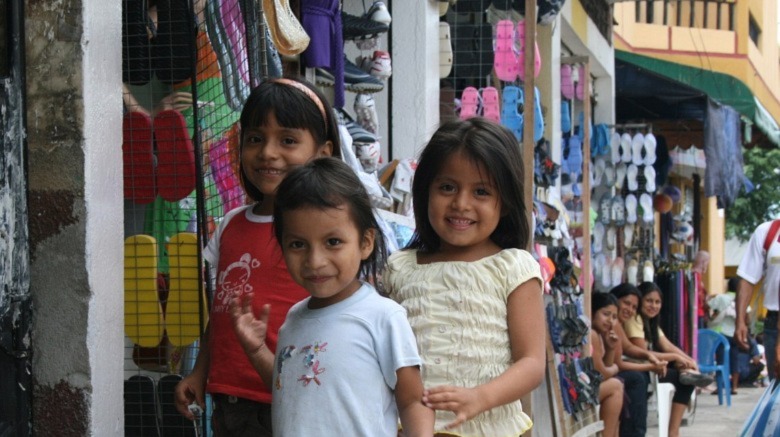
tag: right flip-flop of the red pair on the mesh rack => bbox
[154,110,195,202]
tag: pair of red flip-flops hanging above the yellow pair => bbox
[122,110,195,204]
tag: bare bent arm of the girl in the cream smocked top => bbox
[423,280,546,428]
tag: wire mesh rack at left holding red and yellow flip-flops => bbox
[121,0,278,436]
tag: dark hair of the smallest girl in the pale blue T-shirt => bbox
[273,157,387,292]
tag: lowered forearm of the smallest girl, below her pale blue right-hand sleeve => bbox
[395,366,435,437]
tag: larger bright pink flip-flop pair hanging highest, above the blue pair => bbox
[493,20,542,82]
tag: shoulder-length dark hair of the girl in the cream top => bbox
[407,117,530,252]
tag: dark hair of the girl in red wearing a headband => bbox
[239,77,341,201]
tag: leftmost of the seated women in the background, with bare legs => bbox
[590,293,623,437]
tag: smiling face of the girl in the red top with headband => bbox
[241,113,333,215]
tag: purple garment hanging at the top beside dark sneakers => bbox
[301,0,344,108]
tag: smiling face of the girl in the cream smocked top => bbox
[428,153,501,261]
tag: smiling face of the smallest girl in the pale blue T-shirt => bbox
[281,205,374,308]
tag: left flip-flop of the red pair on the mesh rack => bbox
[122,111,157,204]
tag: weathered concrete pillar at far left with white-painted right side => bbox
[25,0,124,436]
